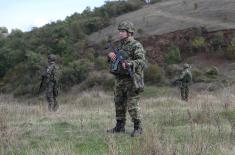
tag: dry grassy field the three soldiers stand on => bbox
[0,87,235,155]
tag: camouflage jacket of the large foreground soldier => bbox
[116,37,146,89]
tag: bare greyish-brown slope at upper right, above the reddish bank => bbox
[89,0,235,43]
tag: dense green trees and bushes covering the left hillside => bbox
[0,0,147,94]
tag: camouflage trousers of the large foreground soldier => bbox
[114,78,140,121]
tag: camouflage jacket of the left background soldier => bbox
[42,62,59,83]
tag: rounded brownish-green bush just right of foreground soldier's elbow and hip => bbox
[145,64,164,84]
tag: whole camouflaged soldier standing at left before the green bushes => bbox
[42,54,59,111]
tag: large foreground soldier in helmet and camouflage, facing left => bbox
[107,21,146,137]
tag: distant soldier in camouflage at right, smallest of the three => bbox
[179,64,192,101]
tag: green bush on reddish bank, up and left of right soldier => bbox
[165,44,181,64]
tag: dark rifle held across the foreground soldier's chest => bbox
[108,43,133,77]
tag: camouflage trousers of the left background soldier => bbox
[46,82,59,111]
